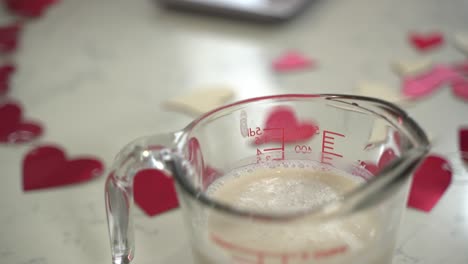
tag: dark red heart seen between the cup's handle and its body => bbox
[133,169,179,216]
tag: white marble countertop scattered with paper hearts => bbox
[0,0,468,264]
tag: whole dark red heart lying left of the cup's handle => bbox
[23,146,104,191]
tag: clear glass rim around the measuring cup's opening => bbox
[173,94,430,221]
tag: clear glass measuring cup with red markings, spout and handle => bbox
[105,94,429,264]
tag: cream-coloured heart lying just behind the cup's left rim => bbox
[164,86,234,116]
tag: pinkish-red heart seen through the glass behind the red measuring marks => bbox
[256,106,319,144]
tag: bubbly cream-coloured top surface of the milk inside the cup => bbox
[207,161,363,213]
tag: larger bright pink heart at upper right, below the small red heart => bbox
[402,65,463,99]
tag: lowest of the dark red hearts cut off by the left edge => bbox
[0,102,42,143]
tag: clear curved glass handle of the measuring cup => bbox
[105,132,182,264]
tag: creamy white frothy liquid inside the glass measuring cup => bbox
[195,161,391,264]
